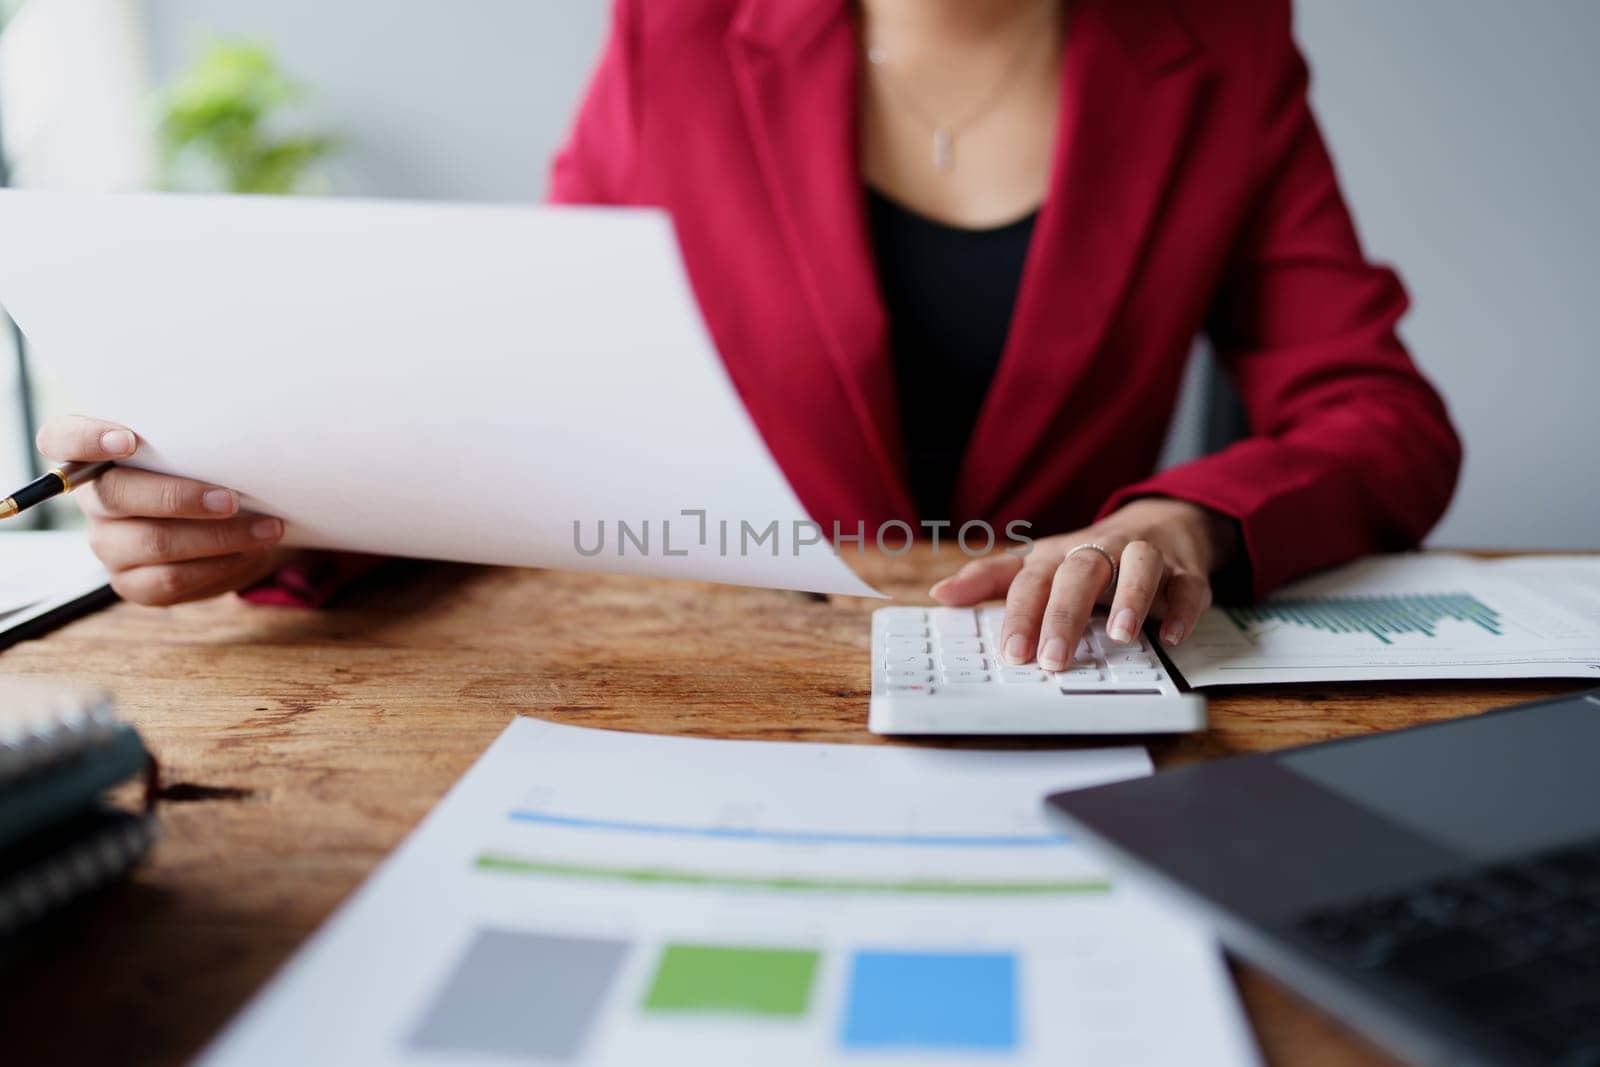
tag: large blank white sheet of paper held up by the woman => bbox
[0,192,877,595]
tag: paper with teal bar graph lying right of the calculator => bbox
[1168,552,1600,686]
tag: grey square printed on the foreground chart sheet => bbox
[411,929,627,1059]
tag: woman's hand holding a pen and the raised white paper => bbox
[38,414,283,605]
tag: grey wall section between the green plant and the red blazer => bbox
[144,0,610,202]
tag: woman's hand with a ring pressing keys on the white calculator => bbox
[930,496,1238,670]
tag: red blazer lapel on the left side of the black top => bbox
[728,0,915,518]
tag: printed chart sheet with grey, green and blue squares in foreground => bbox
[202,718,1256,1067]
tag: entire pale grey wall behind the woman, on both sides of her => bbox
[144,0,1600,549]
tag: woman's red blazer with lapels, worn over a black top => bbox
[552,0,1461,595]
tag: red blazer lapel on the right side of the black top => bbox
[955,0,1205,515]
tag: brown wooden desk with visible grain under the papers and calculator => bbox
[0,552,1576,1065]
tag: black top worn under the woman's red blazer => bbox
[867,189,1038,518]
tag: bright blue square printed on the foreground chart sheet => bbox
[840,952,1018,1053]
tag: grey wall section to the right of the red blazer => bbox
[1298,0,1600,549]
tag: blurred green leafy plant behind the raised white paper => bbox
[158,40,336,194]
